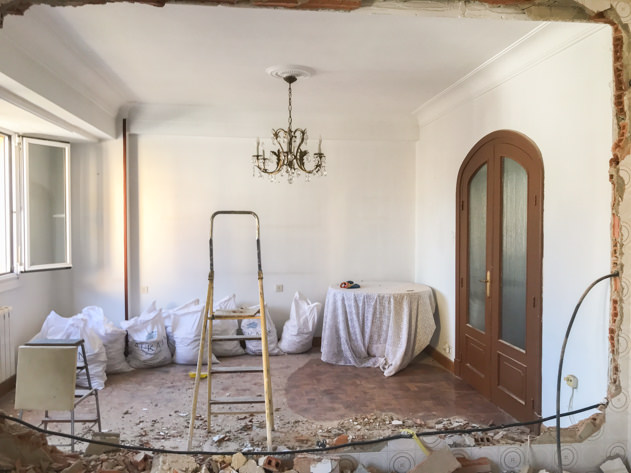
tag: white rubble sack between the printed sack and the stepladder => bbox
[171,299,219,365]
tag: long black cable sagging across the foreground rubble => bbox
[0,403,605,456]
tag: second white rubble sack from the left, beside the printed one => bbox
[75,306,132,373]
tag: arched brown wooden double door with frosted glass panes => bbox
[455,130,543,420]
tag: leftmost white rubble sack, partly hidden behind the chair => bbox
[33,310,107,389]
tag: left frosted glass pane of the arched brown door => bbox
[468,164,487,332]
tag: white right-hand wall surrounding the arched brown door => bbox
[415,26,613,422]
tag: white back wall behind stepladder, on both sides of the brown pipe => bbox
[72,135,415,329]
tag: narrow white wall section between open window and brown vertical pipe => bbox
[62,139,125,320]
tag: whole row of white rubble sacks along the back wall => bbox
[33,292,321,389]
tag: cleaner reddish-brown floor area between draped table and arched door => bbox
[285,354,514,424]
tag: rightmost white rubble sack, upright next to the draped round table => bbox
[278,292,322,353]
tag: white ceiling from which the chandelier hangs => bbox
[0,3,539,140]
